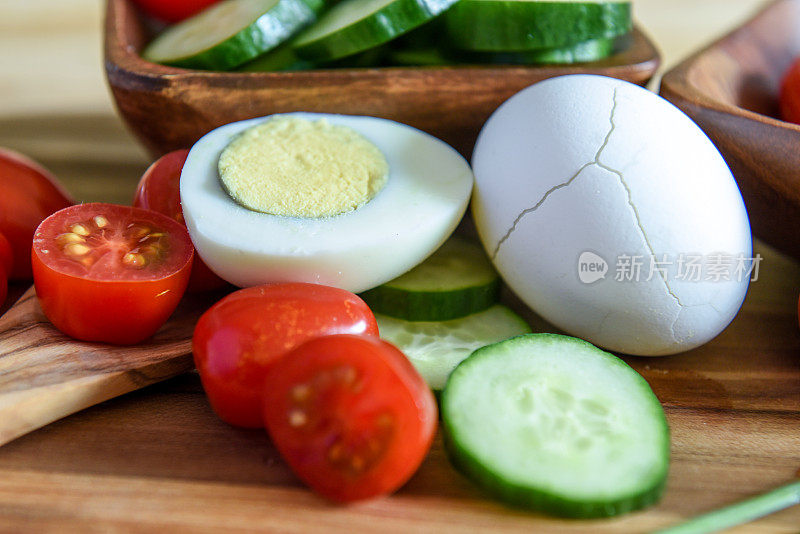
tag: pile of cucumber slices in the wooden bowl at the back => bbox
[143,0,632,71]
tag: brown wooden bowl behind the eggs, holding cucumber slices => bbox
[105,0,660,156]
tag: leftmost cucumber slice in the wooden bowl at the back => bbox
[142,0,324,70]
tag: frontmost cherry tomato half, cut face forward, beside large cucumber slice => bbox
[263,335,437,502]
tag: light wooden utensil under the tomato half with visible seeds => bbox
[0,288,219,446]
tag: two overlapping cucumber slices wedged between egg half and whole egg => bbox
[362,236,531,391]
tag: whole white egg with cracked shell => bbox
[472,75,757,356]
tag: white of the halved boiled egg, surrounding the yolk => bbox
[180,113,473,292]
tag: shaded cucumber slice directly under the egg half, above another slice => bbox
[361,236,500,321]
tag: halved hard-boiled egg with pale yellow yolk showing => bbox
[180,113,473,292]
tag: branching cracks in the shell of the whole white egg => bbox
[492,88,700,344]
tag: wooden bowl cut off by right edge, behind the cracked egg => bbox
[661,0,800,258]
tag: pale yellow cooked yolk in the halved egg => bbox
[219,117,389,218]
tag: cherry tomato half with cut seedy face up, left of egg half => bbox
[32,204,194,345]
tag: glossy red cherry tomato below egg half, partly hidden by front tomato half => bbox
[192,283,378,428]
